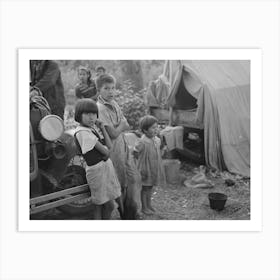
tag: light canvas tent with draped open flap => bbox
[149,60,250,177]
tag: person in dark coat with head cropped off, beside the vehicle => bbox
[30,60,65,119]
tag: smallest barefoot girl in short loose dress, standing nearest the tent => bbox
[134,115,165,215]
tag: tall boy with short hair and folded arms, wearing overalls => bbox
[96,74,141,220]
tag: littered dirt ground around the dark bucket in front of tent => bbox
[32,162,250,220]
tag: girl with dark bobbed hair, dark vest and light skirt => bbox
[75,98,121,220]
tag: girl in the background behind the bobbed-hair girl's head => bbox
[75,66,98,101]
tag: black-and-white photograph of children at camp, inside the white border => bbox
[19,50,260,232]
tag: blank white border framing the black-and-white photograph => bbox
[18,49,262,231]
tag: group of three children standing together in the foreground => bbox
[75,68,165,219]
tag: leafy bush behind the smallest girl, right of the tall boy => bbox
[115,80,148,130]
